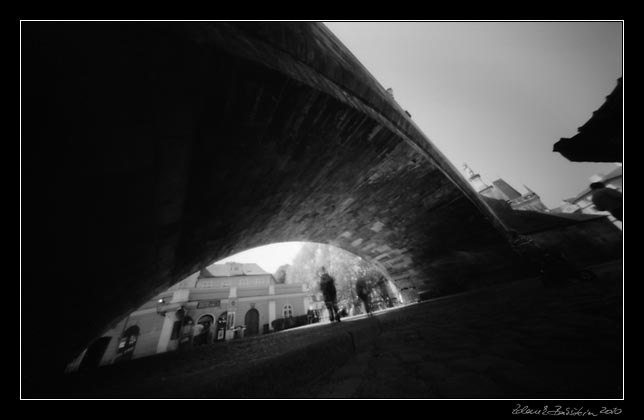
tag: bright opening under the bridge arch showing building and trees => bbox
[69,242,406,372]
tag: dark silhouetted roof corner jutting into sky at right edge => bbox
[553,77,624,162]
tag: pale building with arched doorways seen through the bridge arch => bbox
[68,263,310,371]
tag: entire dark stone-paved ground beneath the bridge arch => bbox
[40,265,623,399]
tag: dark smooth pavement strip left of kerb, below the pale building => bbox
[50,306,380,398]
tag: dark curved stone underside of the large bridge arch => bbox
[21,22,532,381]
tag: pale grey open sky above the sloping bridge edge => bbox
[325,21,623,208]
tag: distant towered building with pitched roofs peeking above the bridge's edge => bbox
[463,164,548,212]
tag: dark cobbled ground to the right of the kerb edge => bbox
[297,264,623,399]
